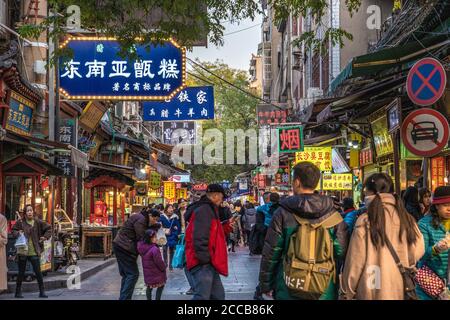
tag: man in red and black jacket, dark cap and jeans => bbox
[185,184,234,300]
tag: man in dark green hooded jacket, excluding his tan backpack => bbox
[259,162,348,299]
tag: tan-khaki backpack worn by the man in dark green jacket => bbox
[283,212,343,299]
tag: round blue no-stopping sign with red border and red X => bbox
[406,58,447,106]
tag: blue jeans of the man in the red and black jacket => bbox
[191,264,225,300]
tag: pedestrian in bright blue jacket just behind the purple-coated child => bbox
[161,204,181,271]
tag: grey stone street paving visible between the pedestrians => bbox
[0,248,260,300]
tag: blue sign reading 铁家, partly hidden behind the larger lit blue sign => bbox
[142,86,214,121]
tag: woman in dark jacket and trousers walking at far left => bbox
[12,205,52,298]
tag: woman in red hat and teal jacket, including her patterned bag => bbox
[416,186,450,300]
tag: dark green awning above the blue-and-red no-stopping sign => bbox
[329,35,450,92]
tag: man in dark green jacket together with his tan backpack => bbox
[259,162,348,300]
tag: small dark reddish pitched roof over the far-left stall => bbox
[3,154,64,176]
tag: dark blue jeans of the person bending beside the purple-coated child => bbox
[114,245,139,300]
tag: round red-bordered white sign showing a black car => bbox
[401,108,449,157]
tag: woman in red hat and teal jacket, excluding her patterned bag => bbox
[416,186,450,300]
